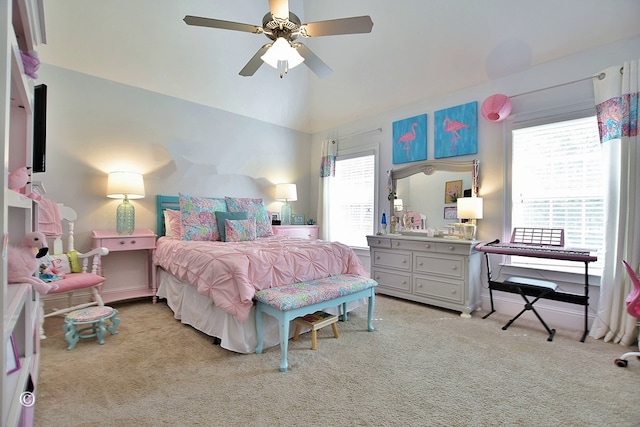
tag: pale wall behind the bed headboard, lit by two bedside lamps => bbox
[33,64,315,298]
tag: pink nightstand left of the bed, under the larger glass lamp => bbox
[92,230,156,303]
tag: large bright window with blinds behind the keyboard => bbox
[511,116,605,269]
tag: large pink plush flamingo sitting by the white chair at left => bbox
[7,232,58,294]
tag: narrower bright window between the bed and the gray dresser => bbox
[329,151,375,248]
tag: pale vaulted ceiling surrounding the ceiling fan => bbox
[38,0,640,132]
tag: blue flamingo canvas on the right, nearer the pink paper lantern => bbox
[433,101,478,159]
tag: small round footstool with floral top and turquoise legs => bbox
[62,305,120,350]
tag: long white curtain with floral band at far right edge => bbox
[591,60,640,345]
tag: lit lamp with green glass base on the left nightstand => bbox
[107,172,144,235]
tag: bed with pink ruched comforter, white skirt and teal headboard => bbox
[153,194,369,353]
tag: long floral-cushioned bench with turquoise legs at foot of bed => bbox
[255,274,378,372]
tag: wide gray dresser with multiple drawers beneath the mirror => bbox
[367,235,481,317]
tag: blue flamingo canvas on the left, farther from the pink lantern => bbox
[392,114,427,165]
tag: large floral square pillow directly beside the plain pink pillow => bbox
[179,193,227,240]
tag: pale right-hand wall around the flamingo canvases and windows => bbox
[311,37,640,329]
